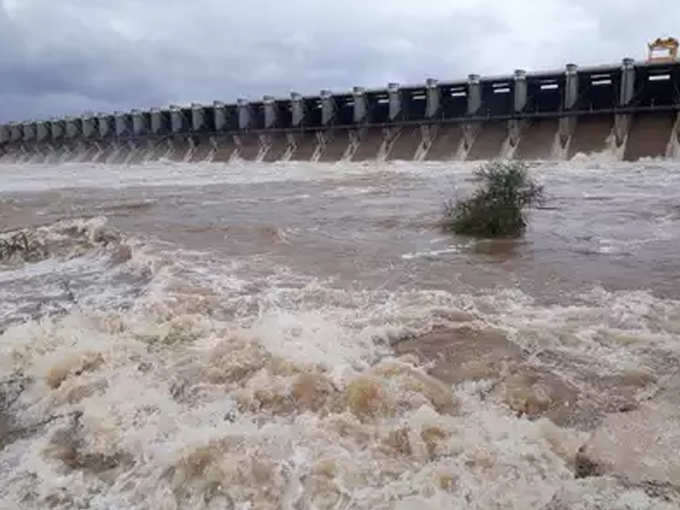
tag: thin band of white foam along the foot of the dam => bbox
[0,158,677,194]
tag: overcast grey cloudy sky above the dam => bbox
[0,0,680,121]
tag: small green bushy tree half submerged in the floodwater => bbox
[444,161,544,237]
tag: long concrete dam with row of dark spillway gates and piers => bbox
[0,59,680,164]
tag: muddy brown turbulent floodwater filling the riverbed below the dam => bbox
[0,159,680,510]
